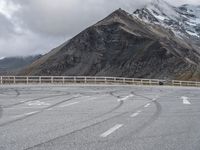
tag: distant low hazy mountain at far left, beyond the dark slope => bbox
[0,55,41,75]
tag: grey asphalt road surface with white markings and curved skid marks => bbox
[0,85,200,150]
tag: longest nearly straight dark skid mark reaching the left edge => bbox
[0,96,81,127]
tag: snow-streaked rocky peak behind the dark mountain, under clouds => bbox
[133,0,200,39]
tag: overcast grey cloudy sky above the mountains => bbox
[0,0,200,59]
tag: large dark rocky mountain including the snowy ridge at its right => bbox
[20,0,200,80]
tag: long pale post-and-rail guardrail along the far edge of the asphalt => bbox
[0,76,200,87]
